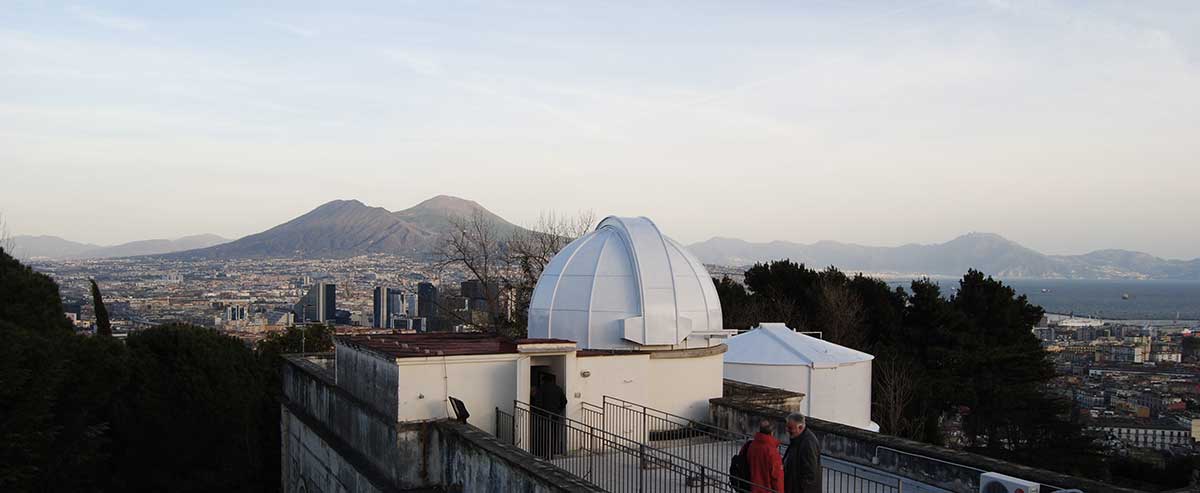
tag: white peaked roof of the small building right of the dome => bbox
[725,323,875,368]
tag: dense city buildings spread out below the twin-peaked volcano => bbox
[29,254,466,341]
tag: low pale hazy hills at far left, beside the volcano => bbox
[12,234,229,259]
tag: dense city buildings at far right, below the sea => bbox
[1034,315,1200,462]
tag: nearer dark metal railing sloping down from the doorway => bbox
[496,401,770,493]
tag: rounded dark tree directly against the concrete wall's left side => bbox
[113,325,278,492]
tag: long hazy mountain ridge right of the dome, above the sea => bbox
[688,233,1200,279]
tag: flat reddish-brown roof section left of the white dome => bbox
[337,332,517,357]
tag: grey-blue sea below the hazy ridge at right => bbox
[888,278,1200,325]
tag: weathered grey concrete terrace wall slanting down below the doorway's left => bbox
[280,356,599,493]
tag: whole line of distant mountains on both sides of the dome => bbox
[13,196,1200,281]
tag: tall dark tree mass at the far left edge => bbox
[0,251,126,491]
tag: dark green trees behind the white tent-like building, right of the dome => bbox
[716,260,1104,477]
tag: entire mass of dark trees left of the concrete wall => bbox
[0,251,282,492]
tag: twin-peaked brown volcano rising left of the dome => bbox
[170,196,516,258]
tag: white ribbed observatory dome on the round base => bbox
[528,216,721,349]
